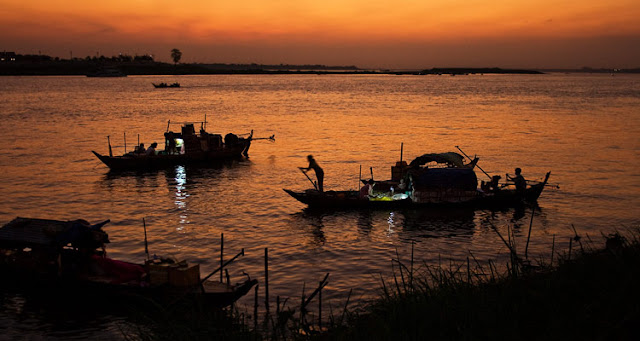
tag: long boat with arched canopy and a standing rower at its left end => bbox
[284,152,551,209]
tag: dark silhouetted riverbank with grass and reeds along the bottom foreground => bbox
[128,227,640,340]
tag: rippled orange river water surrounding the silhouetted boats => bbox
[0,74,640,339]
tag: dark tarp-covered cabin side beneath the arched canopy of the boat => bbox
[412,168,478,191]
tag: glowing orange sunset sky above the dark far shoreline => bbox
[0,0,640,68]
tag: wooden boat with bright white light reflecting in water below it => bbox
[92,121,262,170]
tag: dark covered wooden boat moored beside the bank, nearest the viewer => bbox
[0,217,257,307]
